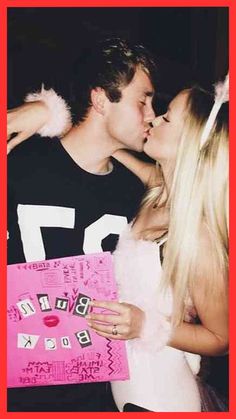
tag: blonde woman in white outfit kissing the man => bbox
[7,77,228,411]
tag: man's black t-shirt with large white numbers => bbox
[8,137,144,411]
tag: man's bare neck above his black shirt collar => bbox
[61,121,117,174]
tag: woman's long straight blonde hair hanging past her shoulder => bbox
[140,87,228,325]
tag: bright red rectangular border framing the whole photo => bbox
[0,0,236,418]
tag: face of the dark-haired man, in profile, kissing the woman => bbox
[103,69,155,151]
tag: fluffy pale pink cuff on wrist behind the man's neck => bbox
[25,85,72,137]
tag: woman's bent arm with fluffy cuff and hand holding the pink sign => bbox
[84,228,228,356]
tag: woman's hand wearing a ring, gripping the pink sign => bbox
[86,301,145,340]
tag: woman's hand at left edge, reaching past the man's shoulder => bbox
[7,101,49,153]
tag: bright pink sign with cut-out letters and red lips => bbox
[7,252,129,387]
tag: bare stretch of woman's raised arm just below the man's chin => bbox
[112,150,160,187]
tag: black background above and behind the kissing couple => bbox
[8,7,228,406]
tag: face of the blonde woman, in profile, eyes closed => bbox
[144,91,188,164]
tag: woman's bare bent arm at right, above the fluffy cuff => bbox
[169,230,228,356]
